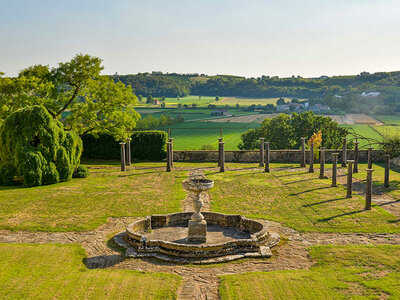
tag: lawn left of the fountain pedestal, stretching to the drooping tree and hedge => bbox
[0,164,187,231]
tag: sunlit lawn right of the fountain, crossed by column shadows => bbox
[207,168,400,233]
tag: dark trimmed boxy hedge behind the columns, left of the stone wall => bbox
[82,131,168,160]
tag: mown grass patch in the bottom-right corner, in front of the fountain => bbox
[219,246,400,299]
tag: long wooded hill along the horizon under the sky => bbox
[112,71,400,98]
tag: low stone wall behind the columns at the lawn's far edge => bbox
[174,149,384,163]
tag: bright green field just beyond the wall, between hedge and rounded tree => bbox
[166,122,259,150]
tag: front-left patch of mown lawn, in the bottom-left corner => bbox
[0,244,181,299]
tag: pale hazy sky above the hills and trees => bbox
[0,0,400,77]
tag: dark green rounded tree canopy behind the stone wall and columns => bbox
[238,112,347,150]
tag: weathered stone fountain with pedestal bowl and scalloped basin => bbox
[114,176,279,264]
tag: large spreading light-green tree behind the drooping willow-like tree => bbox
[0,54,139,139]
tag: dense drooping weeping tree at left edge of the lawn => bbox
[0,106,82,187]
